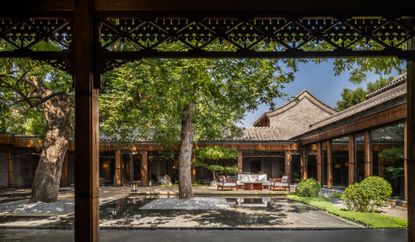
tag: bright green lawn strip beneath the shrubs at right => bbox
[288,194,407,228]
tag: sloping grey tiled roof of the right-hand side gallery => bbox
[299,73,406,136]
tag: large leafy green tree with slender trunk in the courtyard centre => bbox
[101,59,294,198]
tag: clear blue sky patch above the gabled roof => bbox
[238,60,388,127]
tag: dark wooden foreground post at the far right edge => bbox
[406,34,415,242]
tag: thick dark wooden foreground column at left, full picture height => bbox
[71,0,99,242]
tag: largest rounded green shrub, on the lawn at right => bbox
[342,176,392,212]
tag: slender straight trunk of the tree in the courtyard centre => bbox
[179,103,195,199]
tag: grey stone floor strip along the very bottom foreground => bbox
[0,229,407,242]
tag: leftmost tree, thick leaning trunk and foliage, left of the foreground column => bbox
[0,59,74,202]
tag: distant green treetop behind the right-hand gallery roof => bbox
[336,77,393,111]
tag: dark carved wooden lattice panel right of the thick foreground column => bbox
[100,17,414,56]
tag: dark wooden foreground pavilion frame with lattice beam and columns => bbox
[0,0,415,242]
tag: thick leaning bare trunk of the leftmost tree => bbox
[31,91,74,202]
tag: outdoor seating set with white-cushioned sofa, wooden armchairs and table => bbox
[217,174,290,191]
